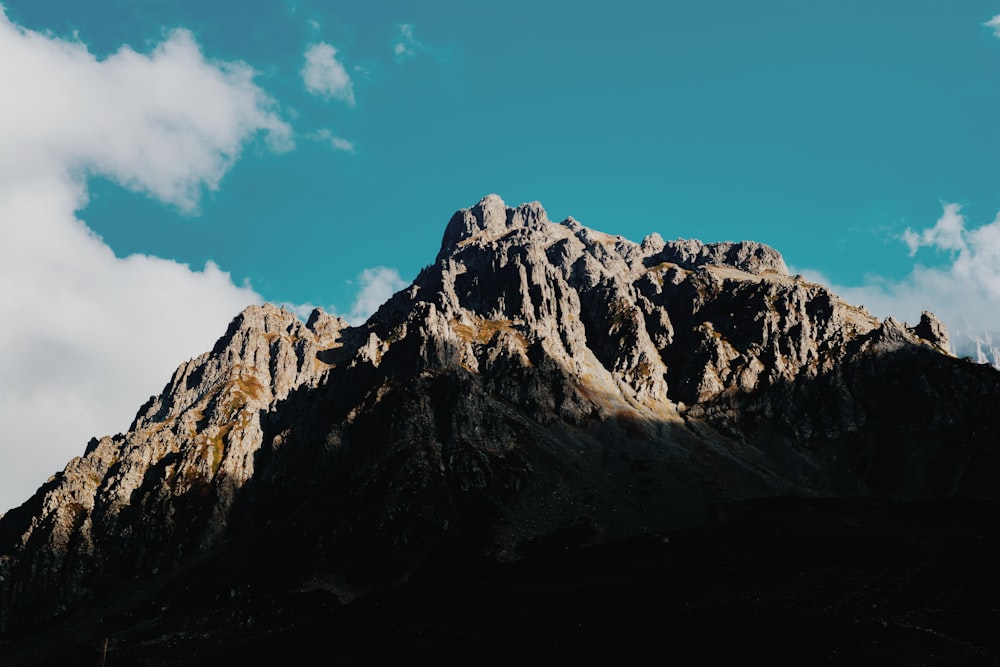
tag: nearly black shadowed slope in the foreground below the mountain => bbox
[0,498,1000,666]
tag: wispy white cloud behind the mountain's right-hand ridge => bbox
[802,204,1000,356]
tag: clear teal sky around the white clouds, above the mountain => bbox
[5,0,1000,310]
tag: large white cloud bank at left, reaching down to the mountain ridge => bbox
[0,8,292,511]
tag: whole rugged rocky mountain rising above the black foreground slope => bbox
[0,196,1000,662]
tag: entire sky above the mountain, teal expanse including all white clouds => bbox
[0,0,1000,512]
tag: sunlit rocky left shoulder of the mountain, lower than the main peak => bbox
[0,306,345,636]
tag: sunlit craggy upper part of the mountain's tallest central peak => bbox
[408,195,908,413]
